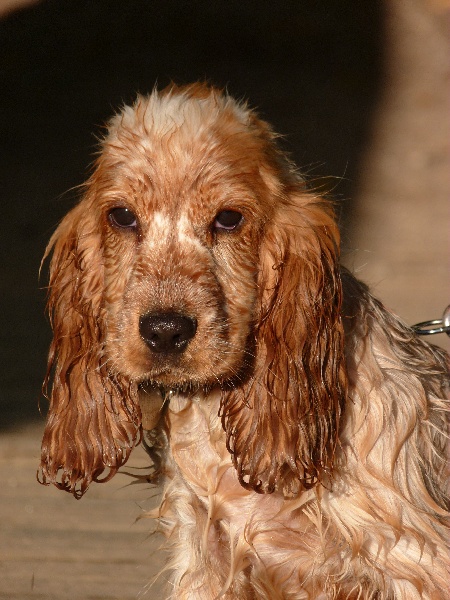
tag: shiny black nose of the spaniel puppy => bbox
[139,313,197,353]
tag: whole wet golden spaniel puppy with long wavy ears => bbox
[39,84,449,600]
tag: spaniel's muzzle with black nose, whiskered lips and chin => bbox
[116,309,253,398]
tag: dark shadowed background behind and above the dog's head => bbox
[0,0,384,428]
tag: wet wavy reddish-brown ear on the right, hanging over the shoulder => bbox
[221,192,346,495]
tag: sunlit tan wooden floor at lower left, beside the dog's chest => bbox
[0,426,165,600]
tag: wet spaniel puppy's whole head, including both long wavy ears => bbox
[41,85,345,495]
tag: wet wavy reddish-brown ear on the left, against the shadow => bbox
[38,199,140,498]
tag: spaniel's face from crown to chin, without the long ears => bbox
[90,89,280,388]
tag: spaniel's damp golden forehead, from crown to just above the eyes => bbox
[101,93,267,218]
